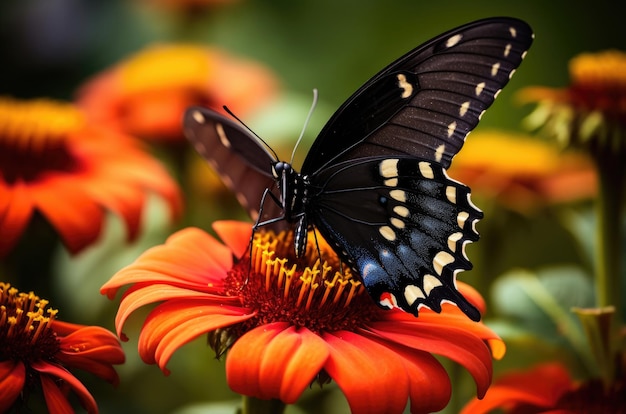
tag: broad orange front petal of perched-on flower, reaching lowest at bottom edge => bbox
[323,331,410,413]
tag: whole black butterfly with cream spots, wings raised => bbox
[184,18,533,321]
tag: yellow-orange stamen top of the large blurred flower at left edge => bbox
[0,97,85,152]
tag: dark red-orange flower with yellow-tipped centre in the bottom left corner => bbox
[0,283,124,413]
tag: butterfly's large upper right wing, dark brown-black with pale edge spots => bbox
[302,18,533,175]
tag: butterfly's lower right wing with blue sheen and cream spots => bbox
[311,156,483,320]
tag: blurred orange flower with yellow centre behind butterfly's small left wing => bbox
[78,44,276,140]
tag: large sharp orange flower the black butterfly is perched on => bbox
[101,222,504,413]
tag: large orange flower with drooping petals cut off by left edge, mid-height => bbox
[0,98,181,256]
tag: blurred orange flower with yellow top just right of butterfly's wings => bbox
[449,131,597,213]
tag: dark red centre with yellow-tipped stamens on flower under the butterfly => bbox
[225,231,380,337]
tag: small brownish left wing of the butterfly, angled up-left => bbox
[183,107,281,221]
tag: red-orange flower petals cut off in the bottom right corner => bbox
[462,363,626,414]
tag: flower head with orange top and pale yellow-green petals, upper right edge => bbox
[520,50,626,153]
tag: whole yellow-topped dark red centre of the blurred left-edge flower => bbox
[0,98,83,184]
